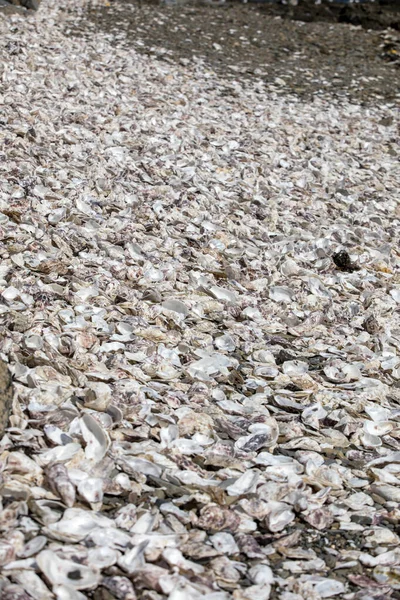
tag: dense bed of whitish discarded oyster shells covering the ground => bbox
[0,0,400,600]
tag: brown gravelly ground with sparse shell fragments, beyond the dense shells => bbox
[72,0,400,104]
